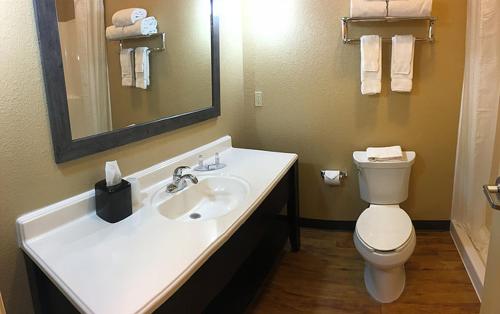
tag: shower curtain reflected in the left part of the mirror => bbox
[71,0,111,136]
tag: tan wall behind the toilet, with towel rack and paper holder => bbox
[243,0,466,220]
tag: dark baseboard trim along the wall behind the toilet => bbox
[300,218,450,231]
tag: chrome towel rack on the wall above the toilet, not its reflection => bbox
[340,16,437,44]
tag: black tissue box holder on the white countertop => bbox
[95,180,132,223]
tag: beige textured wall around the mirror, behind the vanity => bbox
[0,0,243,314]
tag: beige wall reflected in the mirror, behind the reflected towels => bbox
[104,0,212,129]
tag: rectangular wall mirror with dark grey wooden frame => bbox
[34,0,220,163]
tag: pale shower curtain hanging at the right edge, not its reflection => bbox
[450,0,500,263]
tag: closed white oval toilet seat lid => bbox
[356,205,413,253]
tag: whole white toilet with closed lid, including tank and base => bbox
[353,152,416,303]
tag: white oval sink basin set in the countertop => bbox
[153,176,249,221]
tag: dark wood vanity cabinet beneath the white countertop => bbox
[25,162,300,314]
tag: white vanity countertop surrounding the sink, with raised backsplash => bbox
[17,136,297,313]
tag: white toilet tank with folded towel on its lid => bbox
[353,152,416,205]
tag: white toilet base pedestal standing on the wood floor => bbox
[364,261,406,303]
